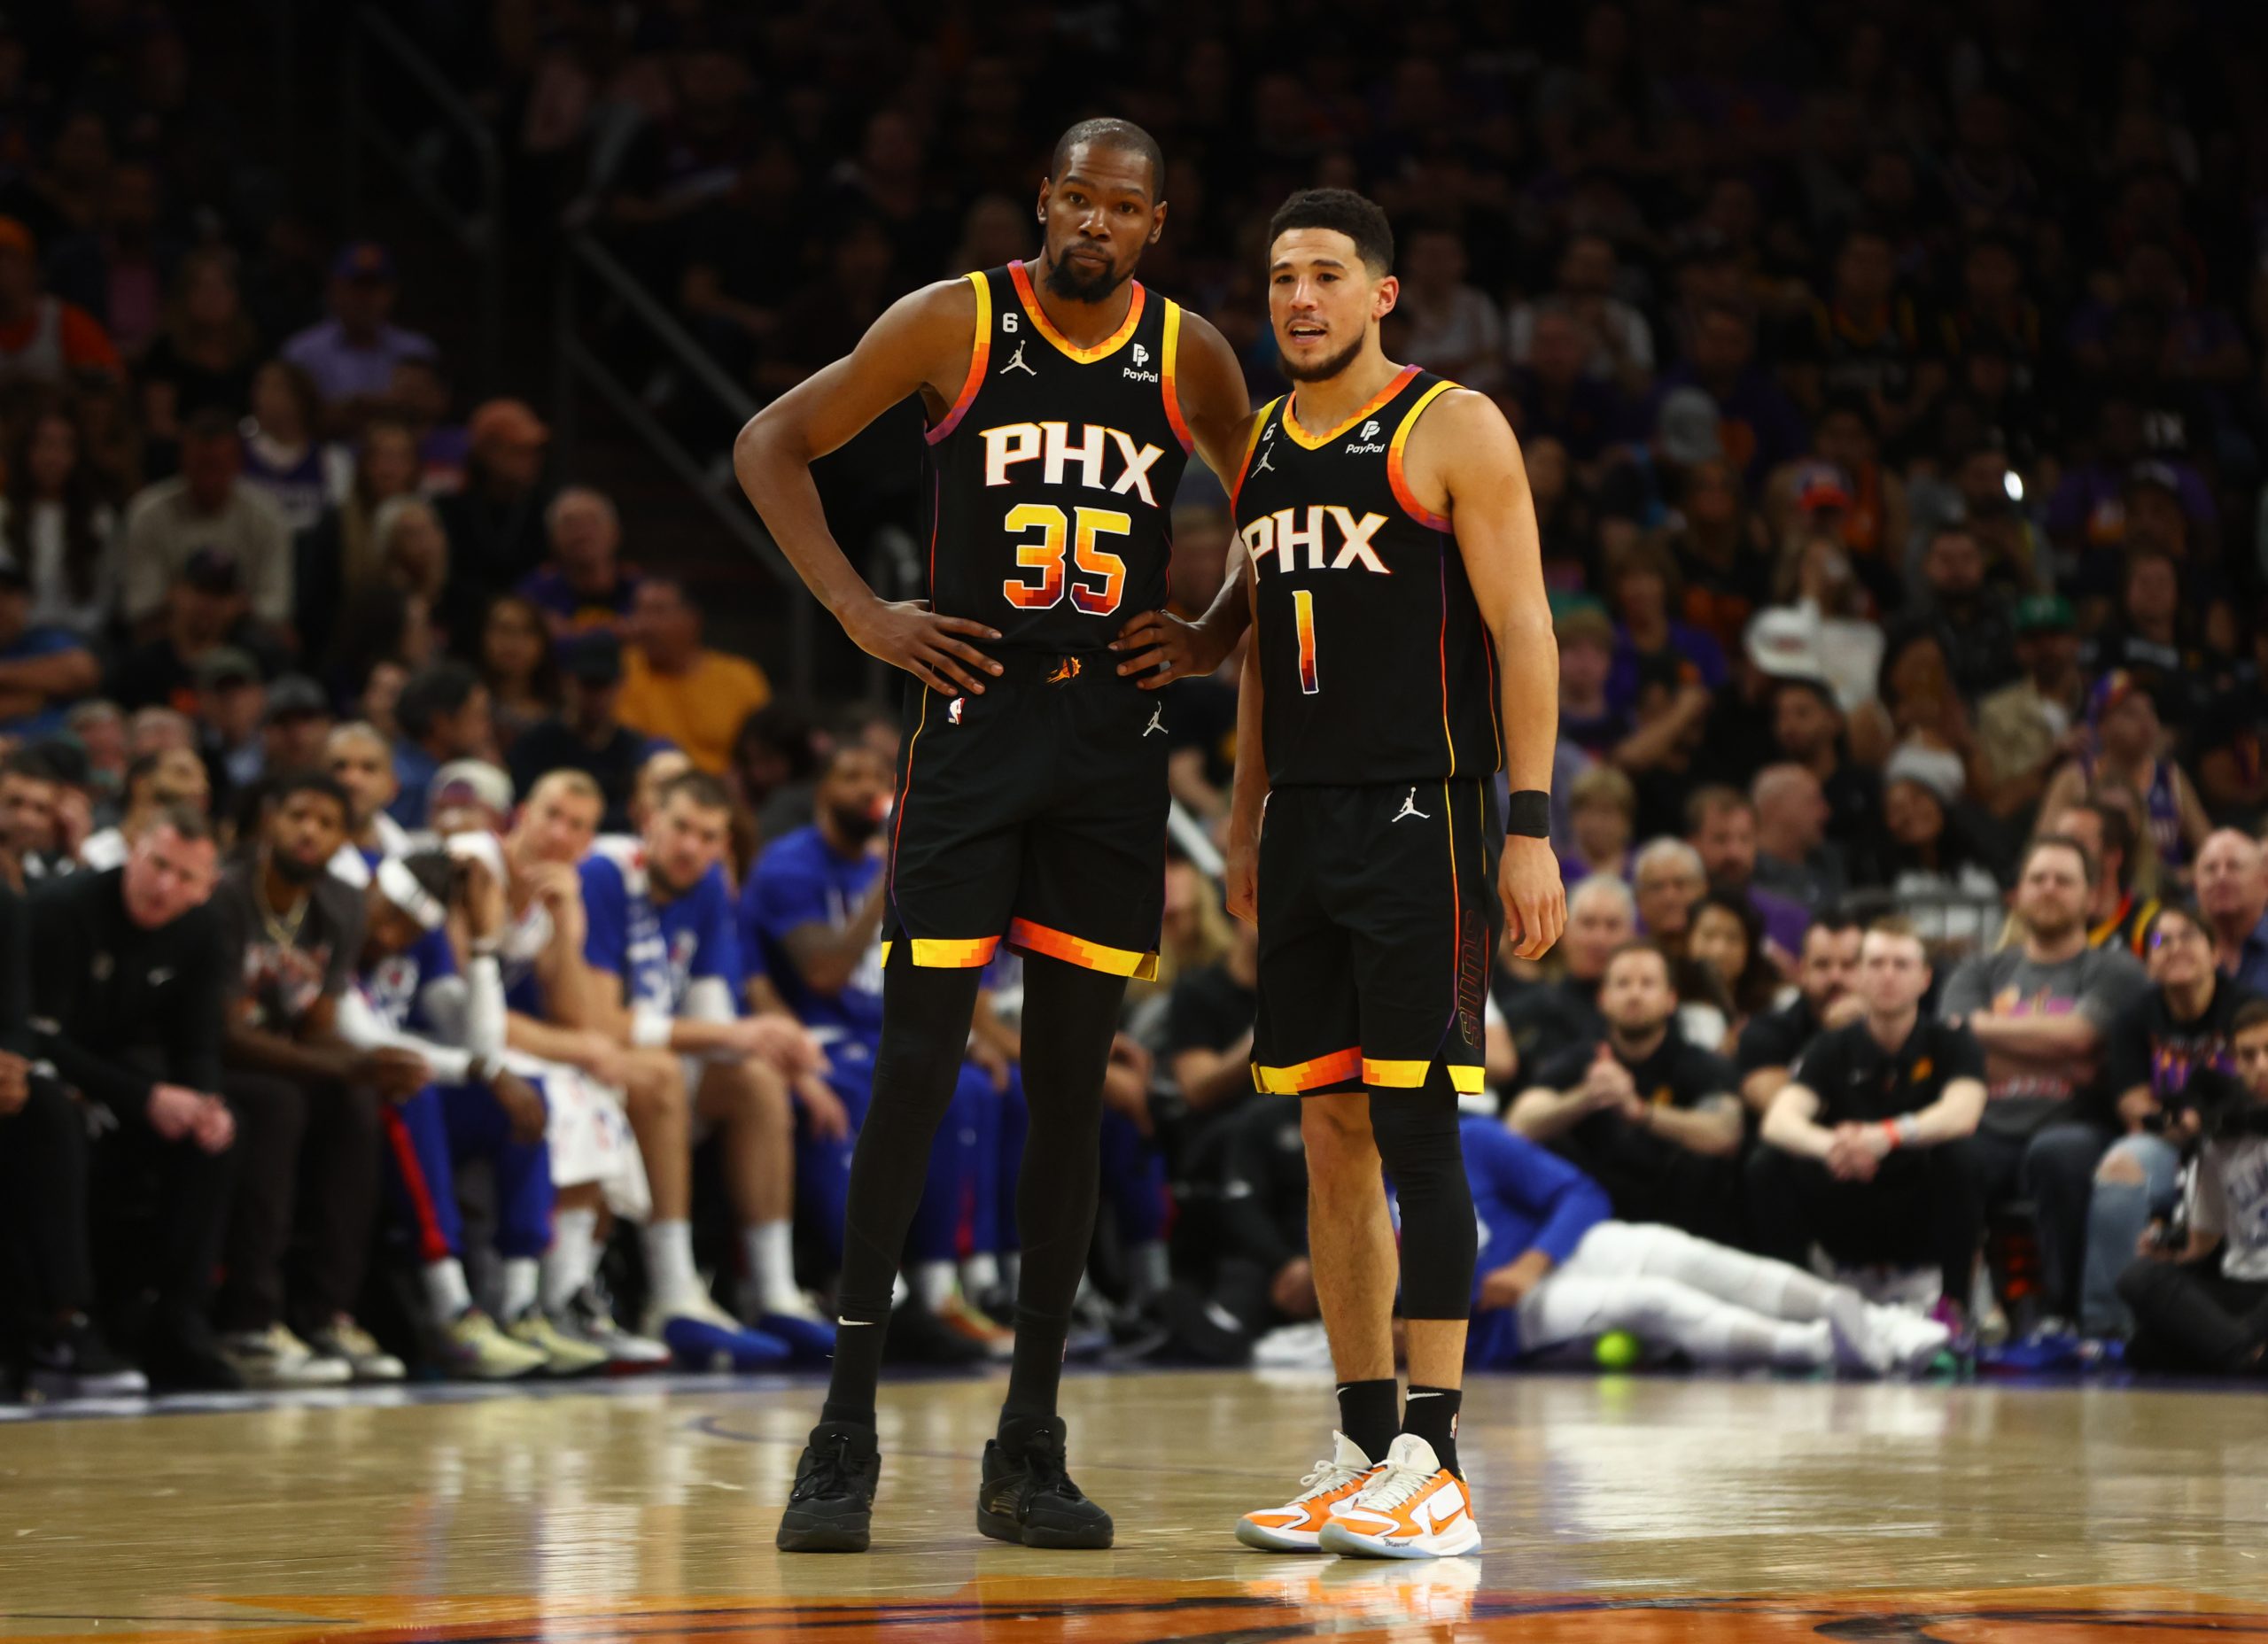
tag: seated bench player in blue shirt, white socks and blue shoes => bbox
[583,771,835,1365]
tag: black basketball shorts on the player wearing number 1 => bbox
[1252,780,1503,1095]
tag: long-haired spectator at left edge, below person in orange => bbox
[0,401,118,641]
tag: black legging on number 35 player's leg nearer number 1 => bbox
[1000,955,1127,1424]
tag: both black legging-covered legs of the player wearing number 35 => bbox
[826,955,1125,1424]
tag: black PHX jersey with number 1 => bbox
[1231,365,1503,787]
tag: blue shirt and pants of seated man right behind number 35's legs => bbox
[740,826,1002,1263]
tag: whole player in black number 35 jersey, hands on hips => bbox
[734,120,1250,1551]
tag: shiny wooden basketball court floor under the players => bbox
[0,1372,2268,1644]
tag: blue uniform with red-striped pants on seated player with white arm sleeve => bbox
[369,930,558,1260]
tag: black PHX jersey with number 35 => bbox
[928,263,1191,651]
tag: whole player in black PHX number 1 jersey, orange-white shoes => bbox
[1230,188,1567,1558]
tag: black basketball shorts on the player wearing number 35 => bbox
[882,647,1168,980]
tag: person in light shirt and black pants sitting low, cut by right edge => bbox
[2118,1000,2268,1376]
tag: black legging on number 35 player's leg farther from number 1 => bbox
[821,946,982,1426]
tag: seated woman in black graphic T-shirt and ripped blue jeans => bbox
[2080,903,2259,1336]
